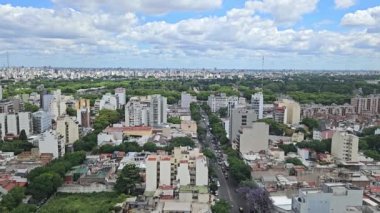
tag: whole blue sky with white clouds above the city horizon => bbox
[0,0,380,70]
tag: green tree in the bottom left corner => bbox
[0,187,25,212]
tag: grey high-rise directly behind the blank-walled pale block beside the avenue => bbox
[228,108,257,143]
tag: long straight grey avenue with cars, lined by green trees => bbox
[200,111,247,212]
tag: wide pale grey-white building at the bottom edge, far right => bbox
[292,183,363,213]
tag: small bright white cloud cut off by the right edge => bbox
[341,6,380,28]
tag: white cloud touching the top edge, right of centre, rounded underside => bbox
[246,0,319,23]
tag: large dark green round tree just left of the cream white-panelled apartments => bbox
[115,164,141,195]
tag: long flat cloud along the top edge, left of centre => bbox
[53,0,222,14]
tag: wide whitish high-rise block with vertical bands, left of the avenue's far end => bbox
[125,95,167,126]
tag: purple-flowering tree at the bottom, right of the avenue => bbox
[238,187,273,213]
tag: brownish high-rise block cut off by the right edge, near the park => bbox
[351,95,380,115]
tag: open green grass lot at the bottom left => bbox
[38,192,126,213]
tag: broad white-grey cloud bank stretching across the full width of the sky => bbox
[0,0,380,65]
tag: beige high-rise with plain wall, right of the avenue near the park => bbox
[274,99,301,125]
